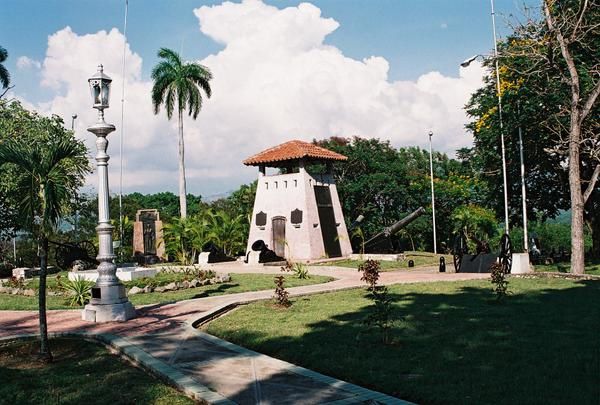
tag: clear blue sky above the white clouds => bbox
[0,0,522,98]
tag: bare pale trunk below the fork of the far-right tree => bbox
[569,118,585,274]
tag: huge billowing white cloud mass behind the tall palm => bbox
[23,0,483,195]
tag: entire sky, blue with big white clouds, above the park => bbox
[0,0,536,197]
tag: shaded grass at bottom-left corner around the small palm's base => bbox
[0,339,194,405]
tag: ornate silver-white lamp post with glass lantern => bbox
[82,65,135,322]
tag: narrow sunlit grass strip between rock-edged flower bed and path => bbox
[0,273,333,310]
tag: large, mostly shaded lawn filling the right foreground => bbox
[205,278,600,404]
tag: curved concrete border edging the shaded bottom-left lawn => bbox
[0,332,235,405]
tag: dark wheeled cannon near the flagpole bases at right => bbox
[452,230,512,274]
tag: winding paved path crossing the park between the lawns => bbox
[0,263,489,404]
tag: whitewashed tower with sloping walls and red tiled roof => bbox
[243,140,352,261]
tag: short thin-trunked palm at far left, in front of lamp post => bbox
[0,139,88,362]
